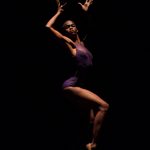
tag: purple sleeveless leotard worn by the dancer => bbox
[62,43,93,88]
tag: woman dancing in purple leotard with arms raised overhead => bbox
[46,0,109,150]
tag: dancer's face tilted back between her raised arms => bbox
[63,20,78,35]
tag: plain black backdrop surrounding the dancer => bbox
[1,0,149,150]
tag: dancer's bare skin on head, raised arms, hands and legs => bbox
[46,0,109,150]
